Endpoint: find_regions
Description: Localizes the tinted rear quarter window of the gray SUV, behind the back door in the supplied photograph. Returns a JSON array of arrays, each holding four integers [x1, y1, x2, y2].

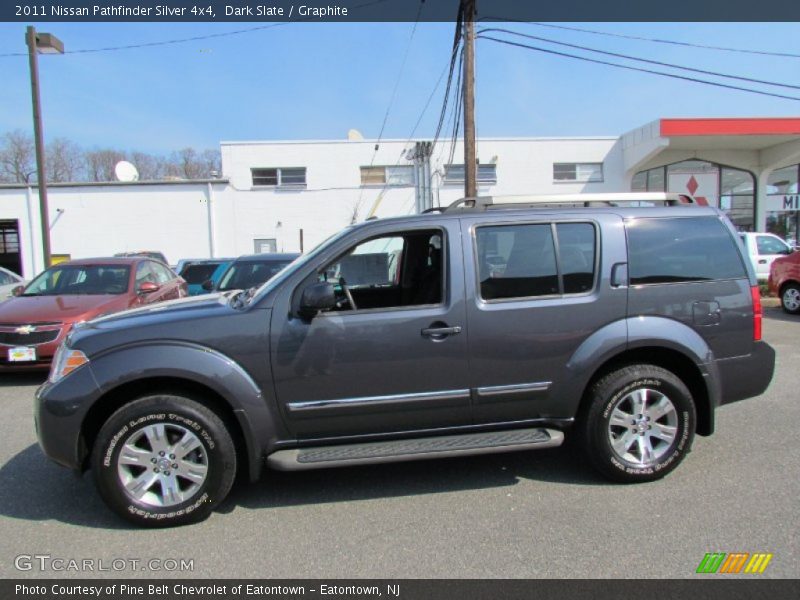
[[626, 217, 747, 285]]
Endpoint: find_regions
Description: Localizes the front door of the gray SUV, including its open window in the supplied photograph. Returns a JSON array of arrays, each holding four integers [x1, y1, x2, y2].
[[271, 220, 470, 438]]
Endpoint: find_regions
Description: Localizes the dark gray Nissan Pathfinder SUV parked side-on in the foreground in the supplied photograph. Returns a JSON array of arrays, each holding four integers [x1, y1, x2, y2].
[[36, 194, 775, 525]]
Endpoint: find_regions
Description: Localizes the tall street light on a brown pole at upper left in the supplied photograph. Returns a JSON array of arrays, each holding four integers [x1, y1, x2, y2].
[[25, 26, 64, 269]]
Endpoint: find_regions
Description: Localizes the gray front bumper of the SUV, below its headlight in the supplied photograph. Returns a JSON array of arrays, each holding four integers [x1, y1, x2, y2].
[[34, 364, 100, 471]]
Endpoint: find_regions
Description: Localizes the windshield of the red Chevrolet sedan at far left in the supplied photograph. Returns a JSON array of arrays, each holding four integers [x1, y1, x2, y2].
[[21, 265, 131, 296]]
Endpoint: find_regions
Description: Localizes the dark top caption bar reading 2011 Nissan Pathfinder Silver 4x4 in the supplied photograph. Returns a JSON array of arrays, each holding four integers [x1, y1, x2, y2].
[[0, 0, 800, 22]]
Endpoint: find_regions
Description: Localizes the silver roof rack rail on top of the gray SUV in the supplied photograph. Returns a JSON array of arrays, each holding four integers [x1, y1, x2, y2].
[[444, 192, 698, 212]]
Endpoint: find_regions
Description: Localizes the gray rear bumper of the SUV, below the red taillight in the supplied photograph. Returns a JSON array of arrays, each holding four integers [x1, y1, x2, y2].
[[717, 342, 775, 404]]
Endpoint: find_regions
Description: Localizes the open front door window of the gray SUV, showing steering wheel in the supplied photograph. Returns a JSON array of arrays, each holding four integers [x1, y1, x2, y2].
[[319, 229, 445, 311]]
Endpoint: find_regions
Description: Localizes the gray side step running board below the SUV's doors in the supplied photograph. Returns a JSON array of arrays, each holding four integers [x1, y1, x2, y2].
[[267, 428, 564, 471]]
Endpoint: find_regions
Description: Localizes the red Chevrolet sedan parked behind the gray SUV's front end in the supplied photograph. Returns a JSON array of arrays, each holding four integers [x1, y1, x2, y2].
[[0, 257, 187, 370]]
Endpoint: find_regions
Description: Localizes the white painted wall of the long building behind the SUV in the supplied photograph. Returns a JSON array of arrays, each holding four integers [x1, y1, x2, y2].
[[0, 138, 644, 277]]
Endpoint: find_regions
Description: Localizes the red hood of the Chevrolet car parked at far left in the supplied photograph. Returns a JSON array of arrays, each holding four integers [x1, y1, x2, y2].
[[0, 294, 128, 323]]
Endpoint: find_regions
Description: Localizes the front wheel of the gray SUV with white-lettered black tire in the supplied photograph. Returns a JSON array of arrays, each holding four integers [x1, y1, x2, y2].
[[92, 394, 236, 527]]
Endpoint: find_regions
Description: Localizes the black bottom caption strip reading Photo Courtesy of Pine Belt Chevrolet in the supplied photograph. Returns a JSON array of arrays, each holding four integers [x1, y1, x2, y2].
[[0, 576, 800, 600]]
